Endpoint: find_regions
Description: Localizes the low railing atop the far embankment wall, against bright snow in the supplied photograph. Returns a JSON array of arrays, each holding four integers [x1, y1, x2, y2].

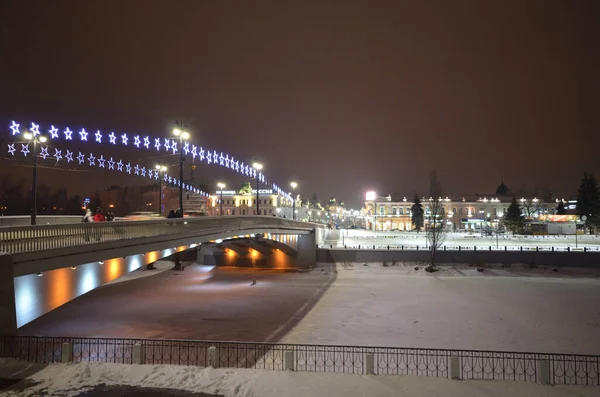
[[317, 244, 600, 252]]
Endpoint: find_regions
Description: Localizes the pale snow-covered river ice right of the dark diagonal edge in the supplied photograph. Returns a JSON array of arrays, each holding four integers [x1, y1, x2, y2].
[[282, 263, 600, 354]]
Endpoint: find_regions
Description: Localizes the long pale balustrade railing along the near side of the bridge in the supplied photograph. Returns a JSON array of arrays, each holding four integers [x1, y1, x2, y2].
[[0, 216, 315, 254]]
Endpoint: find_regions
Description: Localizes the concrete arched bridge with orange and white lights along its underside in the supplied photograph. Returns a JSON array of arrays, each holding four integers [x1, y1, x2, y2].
[[0, 216, 322, 333]]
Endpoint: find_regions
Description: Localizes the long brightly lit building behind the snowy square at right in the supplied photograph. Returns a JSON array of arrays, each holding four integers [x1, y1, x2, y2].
[[362, 183, 568, 231]]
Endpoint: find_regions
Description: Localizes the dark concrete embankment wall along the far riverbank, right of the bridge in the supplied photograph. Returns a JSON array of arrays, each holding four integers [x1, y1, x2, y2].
[[317, 249, 600, 267]]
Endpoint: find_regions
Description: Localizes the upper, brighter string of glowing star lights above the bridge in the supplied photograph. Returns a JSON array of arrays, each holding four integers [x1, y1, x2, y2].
[[9, 121, 294, 200]]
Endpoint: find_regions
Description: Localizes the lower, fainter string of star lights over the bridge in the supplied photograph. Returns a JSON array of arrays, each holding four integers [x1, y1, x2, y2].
[[8, 138, 209, 197]]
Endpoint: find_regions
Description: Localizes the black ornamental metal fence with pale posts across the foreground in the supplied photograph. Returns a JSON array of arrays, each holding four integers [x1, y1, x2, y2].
[[0, 336, 600, 386]]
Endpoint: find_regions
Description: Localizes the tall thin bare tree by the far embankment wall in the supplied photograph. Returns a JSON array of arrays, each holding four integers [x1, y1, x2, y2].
[[425, 170, 446, 272]]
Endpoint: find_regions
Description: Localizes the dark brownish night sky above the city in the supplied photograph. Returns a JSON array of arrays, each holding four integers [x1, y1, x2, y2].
[[0, 0, 600, 205]]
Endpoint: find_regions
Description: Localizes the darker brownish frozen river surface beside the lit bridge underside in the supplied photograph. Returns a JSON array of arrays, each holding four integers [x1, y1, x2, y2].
[[18, 265, 336, 342]]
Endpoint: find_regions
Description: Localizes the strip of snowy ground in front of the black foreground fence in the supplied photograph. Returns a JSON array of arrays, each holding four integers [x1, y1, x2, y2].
[[0, 360, 599, 397]]
